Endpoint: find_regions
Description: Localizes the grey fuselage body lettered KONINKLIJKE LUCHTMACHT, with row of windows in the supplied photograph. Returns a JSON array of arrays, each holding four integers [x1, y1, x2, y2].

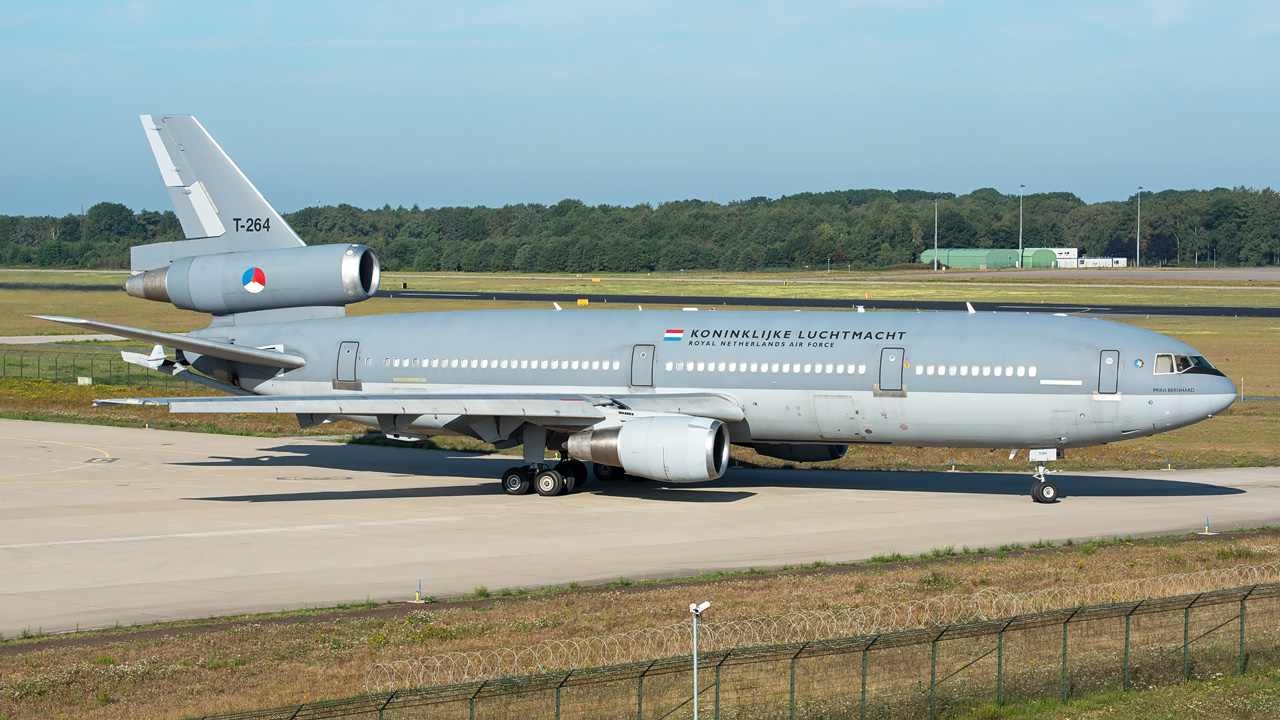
[[192, 310, 1236, 448]]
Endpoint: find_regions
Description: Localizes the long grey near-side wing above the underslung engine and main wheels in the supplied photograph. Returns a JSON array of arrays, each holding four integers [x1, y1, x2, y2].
[[93, 392, 744, 425]]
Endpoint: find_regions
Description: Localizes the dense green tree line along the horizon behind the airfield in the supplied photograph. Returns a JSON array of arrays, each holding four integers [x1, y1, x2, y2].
[[0, 187, 1280, 273]]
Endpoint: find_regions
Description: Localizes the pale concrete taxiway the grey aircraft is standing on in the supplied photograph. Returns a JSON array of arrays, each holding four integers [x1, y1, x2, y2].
[[0, 420, 1280, 637]]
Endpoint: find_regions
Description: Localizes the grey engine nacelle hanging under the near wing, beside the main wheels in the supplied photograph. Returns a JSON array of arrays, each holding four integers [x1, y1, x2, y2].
[[567, 415, 728, 483]]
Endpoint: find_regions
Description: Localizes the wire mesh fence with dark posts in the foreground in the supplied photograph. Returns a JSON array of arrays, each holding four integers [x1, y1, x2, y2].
[[189, 583, 1280, 720]]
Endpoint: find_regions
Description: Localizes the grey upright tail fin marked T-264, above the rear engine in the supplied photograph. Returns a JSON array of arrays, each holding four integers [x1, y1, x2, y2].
[[131, 115, 305, 273]]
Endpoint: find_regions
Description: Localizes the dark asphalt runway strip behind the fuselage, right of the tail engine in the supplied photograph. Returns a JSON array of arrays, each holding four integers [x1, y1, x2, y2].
[[381, 290, 1280, 318]]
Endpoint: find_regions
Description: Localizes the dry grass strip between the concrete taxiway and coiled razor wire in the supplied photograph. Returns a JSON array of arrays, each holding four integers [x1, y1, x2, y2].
[[0, 534, 1280, 719]]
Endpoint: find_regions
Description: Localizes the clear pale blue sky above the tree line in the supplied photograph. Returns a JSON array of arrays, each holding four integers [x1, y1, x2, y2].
[[0, 0, 1280, 215]]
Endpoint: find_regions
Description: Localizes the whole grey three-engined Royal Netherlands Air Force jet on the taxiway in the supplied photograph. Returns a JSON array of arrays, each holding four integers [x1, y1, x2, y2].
[[46, 115, 1236, 502]]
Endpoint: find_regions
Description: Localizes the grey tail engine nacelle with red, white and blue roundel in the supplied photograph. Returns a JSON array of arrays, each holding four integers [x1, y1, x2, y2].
[[124, 245, 381, 315]]
